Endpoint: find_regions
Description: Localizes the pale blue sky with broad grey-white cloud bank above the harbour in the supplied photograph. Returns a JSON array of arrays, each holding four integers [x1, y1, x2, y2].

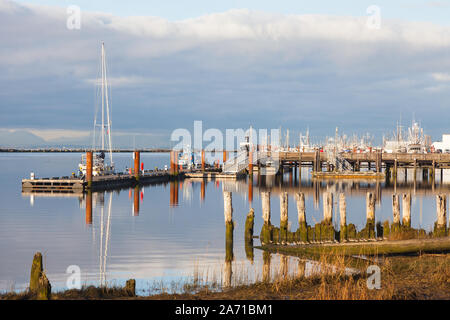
[[0, 0, 450, 146]]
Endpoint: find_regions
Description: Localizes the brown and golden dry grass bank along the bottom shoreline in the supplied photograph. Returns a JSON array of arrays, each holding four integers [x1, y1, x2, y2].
[[0, 254, 450, 300]]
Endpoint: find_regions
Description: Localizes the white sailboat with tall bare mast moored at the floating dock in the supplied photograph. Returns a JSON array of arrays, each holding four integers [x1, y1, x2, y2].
[[78, 42, 115, 176]]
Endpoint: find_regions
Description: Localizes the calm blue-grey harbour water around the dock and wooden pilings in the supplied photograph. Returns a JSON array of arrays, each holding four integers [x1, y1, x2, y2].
[[0, 153, 450, 294]]
